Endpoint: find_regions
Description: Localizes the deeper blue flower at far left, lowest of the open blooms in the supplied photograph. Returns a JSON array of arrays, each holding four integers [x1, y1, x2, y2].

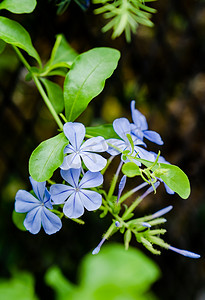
[[15, 177, 62, 234]]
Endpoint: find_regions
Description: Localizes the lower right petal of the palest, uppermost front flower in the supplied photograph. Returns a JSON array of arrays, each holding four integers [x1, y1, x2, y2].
[[81, 152, 107, 172]]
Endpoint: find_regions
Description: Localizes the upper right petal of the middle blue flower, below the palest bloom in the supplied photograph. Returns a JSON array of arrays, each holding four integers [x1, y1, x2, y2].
[[79, 171, 103, 189]]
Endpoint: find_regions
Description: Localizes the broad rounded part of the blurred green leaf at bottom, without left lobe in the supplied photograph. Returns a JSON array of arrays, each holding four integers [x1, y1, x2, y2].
[[79, 244, 160, 299]]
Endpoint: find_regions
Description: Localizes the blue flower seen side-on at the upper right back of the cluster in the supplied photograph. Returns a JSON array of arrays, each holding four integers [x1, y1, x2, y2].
[[131, 100, 164, 145]]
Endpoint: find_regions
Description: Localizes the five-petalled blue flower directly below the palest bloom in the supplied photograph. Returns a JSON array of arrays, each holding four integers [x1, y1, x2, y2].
[[50, 169, 103, 219]]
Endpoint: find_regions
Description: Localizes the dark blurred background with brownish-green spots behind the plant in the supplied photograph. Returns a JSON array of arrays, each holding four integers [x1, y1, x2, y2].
[[0, 0, 205, 300]]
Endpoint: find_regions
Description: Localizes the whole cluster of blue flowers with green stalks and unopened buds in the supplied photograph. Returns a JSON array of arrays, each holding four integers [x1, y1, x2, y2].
[[15, 101, 199, 258]]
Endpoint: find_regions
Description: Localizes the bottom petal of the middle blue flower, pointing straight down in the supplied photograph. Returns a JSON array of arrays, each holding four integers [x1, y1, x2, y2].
[[63, 192, 84, 219]]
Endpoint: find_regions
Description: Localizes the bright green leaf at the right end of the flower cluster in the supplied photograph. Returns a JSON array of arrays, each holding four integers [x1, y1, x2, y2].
[[138, 159, 190, 199]]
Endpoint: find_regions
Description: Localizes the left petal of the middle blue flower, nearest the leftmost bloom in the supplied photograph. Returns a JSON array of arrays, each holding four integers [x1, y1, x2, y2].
[[50, 184, 75, 204]]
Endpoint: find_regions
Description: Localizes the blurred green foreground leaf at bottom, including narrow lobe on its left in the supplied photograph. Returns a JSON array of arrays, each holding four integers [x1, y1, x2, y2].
[[46, 244, 160, 300]]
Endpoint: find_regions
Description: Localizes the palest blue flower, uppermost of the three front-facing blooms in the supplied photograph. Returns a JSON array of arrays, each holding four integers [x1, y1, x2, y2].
[[60, 122, 108, 172]]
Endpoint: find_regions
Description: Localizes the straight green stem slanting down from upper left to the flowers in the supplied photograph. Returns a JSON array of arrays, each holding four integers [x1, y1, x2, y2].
[[13, 46, 63, 129]]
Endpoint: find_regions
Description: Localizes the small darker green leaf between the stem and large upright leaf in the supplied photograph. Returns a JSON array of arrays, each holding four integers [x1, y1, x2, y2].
[[41, 78, 64, 114]]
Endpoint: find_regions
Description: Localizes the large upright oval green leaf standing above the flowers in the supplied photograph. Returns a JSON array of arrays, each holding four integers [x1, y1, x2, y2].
[[64, 48, 120, 121]]
